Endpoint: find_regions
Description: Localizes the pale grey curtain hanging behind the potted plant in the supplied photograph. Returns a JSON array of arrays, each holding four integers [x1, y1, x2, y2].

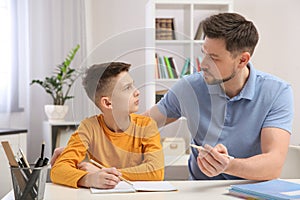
[[26, 0, 86, 160]]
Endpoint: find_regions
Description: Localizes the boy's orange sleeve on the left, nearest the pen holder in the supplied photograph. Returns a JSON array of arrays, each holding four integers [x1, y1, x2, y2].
[[50, 122, 88, 188]]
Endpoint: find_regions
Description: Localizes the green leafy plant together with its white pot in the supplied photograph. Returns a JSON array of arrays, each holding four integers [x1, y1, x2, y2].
[[30, 44, 80, 122]]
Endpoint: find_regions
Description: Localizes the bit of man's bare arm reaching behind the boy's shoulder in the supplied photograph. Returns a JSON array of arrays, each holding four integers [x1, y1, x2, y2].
[[142, 105, 177, 128]]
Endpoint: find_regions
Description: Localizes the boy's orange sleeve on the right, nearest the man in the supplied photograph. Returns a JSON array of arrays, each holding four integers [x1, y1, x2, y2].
[[120, 120, 164, 181]]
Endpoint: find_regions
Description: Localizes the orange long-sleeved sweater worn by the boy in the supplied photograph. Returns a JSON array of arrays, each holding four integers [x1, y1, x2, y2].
[[51, 114, 164, 188]]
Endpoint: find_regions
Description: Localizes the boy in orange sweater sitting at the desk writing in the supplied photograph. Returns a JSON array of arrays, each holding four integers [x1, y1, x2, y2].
[[51, 62, 164, 188]]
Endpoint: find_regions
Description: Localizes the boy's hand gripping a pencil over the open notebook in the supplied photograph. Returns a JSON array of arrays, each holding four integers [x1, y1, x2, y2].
[[78, 167, 121, 189]]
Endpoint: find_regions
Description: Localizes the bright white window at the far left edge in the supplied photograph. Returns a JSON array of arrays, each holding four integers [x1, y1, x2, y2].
[[0, 0, 23, 112]]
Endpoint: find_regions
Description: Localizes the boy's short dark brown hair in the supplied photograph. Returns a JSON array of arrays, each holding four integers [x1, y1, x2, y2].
[[82, 62, 131, 108]]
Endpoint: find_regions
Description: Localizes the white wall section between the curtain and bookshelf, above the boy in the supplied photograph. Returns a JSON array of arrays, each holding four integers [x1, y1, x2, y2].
[[86, 0, 147, 112]]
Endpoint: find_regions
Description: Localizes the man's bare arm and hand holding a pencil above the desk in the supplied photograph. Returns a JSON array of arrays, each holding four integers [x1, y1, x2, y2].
[[197, 128, 290, 180]]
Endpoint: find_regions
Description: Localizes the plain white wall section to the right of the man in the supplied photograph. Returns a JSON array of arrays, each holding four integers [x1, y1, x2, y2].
[[234, 0, 300, 144]]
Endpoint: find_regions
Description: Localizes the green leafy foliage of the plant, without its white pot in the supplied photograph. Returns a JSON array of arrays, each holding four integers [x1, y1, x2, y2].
[[30, 44, 80, 105]]
